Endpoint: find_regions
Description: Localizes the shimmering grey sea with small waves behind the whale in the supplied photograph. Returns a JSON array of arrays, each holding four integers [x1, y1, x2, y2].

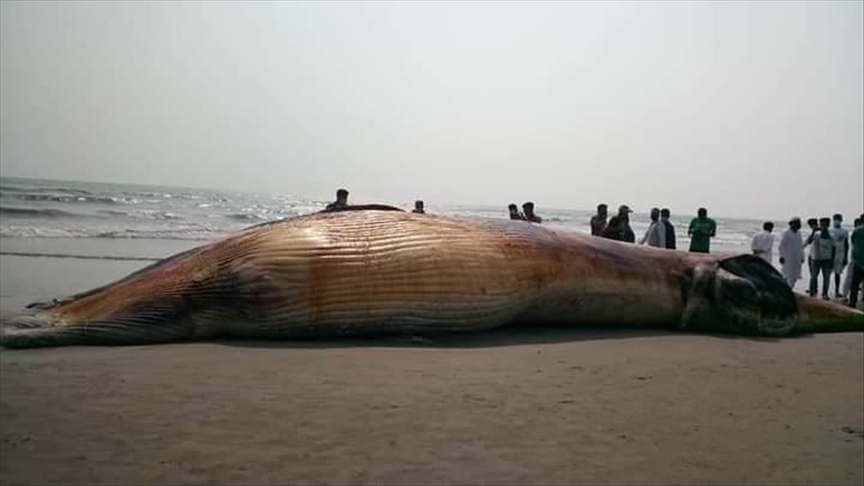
[[0, 177, 785, 258]]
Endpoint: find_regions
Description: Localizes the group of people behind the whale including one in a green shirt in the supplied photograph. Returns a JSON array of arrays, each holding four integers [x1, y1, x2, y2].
[[591, 204, 717, 253]]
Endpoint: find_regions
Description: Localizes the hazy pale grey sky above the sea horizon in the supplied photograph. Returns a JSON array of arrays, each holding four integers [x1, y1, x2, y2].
[[0, 1, 864, 220]]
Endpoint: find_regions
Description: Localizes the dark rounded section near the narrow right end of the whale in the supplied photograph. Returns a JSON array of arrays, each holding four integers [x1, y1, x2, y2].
[[681, 255, 798, 336]]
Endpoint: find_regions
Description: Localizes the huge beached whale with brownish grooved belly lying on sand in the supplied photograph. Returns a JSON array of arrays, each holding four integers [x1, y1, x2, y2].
[[0, 205, 864, 347]]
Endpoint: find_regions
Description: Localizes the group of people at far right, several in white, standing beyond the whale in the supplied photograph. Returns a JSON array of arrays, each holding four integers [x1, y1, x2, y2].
[[776, 214, 864, 307]]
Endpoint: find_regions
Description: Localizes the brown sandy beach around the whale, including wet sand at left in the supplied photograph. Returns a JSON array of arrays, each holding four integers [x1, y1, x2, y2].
[[0, 241, 864, 484]]
